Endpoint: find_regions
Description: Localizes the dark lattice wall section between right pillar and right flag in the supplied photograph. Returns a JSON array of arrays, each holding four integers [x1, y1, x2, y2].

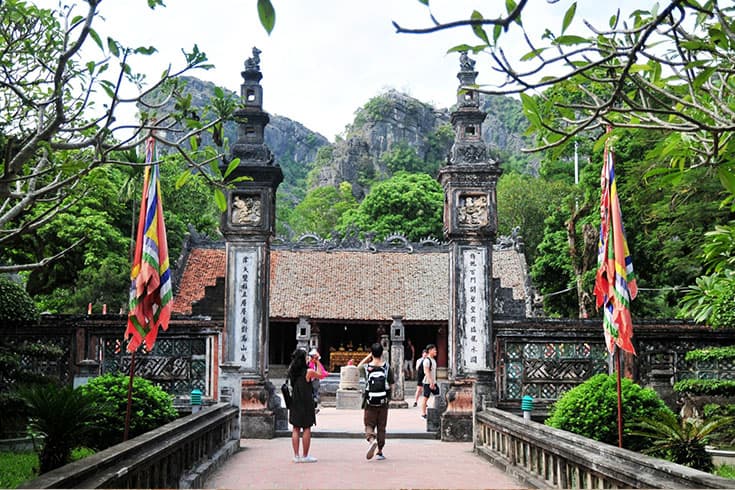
[[499, 340, 607, 401]]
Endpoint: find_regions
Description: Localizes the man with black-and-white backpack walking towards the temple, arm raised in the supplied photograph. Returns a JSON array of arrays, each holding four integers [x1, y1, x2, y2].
[[357, 342, 395, 460]]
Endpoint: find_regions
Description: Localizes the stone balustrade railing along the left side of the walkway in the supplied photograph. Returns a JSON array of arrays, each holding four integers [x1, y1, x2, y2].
[[22, 403, 240, 488]]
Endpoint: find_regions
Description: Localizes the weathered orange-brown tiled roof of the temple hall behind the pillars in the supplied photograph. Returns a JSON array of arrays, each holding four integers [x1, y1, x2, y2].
[[174, 248, 525, 321]]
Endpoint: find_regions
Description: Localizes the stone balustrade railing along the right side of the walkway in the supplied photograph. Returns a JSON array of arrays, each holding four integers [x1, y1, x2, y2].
[[475, 408, 733, 488]]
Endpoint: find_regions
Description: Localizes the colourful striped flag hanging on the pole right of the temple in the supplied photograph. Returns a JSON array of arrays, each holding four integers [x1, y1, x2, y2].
[[595, 127, 638, 354]]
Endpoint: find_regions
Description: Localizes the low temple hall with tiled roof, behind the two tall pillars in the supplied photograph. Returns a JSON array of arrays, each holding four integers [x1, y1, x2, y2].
[[174, 230, 533, 371]]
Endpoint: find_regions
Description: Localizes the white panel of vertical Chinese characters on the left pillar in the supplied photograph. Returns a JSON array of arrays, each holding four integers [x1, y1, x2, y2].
[[235, 251, 258, 368]]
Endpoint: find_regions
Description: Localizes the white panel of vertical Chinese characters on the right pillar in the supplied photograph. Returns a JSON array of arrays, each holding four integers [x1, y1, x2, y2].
[[459, 249, 488, 372]]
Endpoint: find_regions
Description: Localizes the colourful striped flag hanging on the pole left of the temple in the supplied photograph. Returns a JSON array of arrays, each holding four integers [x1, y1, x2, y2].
[[125, 138, 173, 352]]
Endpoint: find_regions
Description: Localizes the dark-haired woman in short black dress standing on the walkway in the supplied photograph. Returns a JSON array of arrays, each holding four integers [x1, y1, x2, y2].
[[288, 349, 319, 463]]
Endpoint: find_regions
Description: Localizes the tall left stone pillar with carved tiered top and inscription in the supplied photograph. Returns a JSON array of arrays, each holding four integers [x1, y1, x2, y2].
[[220, 48, 283, 438]]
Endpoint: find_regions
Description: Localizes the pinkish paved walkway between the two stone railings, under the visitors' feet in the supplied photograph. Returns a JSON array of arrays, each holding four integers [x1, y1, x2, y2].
[[205, 408, 526, 489]]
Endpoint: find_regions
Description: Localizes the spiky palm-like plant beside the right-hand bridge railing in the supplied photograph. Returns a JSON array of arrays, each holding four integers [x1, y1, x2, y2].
[[631, 411, 735, 472]]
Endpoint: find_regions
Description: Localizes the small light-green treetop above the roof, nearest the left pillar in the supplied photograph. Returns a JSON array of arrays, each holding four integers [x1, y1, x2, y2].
[[289, 182, 358, 238]]
